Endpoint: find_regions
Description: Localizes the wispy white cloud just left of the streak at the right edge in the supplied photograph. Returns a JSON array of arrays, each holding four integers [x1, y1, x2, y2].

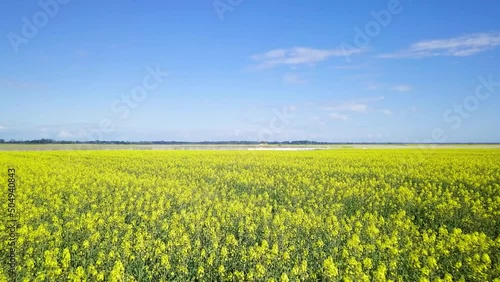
[[251, 47, 364, 69]]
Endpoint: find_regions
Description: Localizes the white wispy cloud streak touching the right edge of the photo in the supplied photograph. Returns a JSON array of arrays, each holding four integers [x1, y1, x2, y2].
[[378, 33, 500, 58]]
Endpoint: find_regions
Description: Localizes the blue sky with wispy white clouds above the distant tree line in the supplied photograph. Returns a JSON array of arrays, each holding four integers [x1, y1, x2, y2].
[[0, 0, 500, 142]]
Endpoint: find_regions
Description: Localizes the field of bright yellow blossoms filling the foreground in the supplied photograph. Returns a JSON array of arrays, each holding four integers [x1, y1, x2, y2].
[[0, 149, 500, 281]]
